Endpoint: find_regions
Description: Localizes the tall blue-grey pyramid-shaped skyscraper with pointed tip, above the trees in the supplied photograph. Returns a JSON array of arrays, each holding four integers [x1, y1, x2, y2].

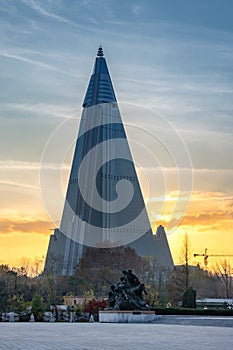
[[45, 47, 173, 275]]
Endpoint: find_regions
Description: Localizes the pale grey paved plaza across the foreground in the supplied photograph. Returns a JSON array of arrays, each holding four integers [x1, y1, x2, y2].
[[0, 322, 233, 350]]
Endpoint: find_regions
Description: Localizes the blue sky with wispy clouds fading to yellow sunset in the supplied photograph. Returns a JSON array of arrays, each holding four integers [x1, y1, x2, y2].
[[0, 0, 233, 266]]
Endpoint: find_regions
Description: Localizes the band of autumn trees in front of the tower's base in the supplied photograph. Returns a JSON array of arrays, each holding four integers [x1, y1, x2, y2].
[[0, 243, 233, 313]]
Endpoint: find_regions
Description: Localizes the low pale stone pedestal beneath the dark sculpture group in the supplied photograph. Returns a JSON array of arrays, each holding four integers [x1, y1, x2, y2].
[[99, 310, 157, 323]]
